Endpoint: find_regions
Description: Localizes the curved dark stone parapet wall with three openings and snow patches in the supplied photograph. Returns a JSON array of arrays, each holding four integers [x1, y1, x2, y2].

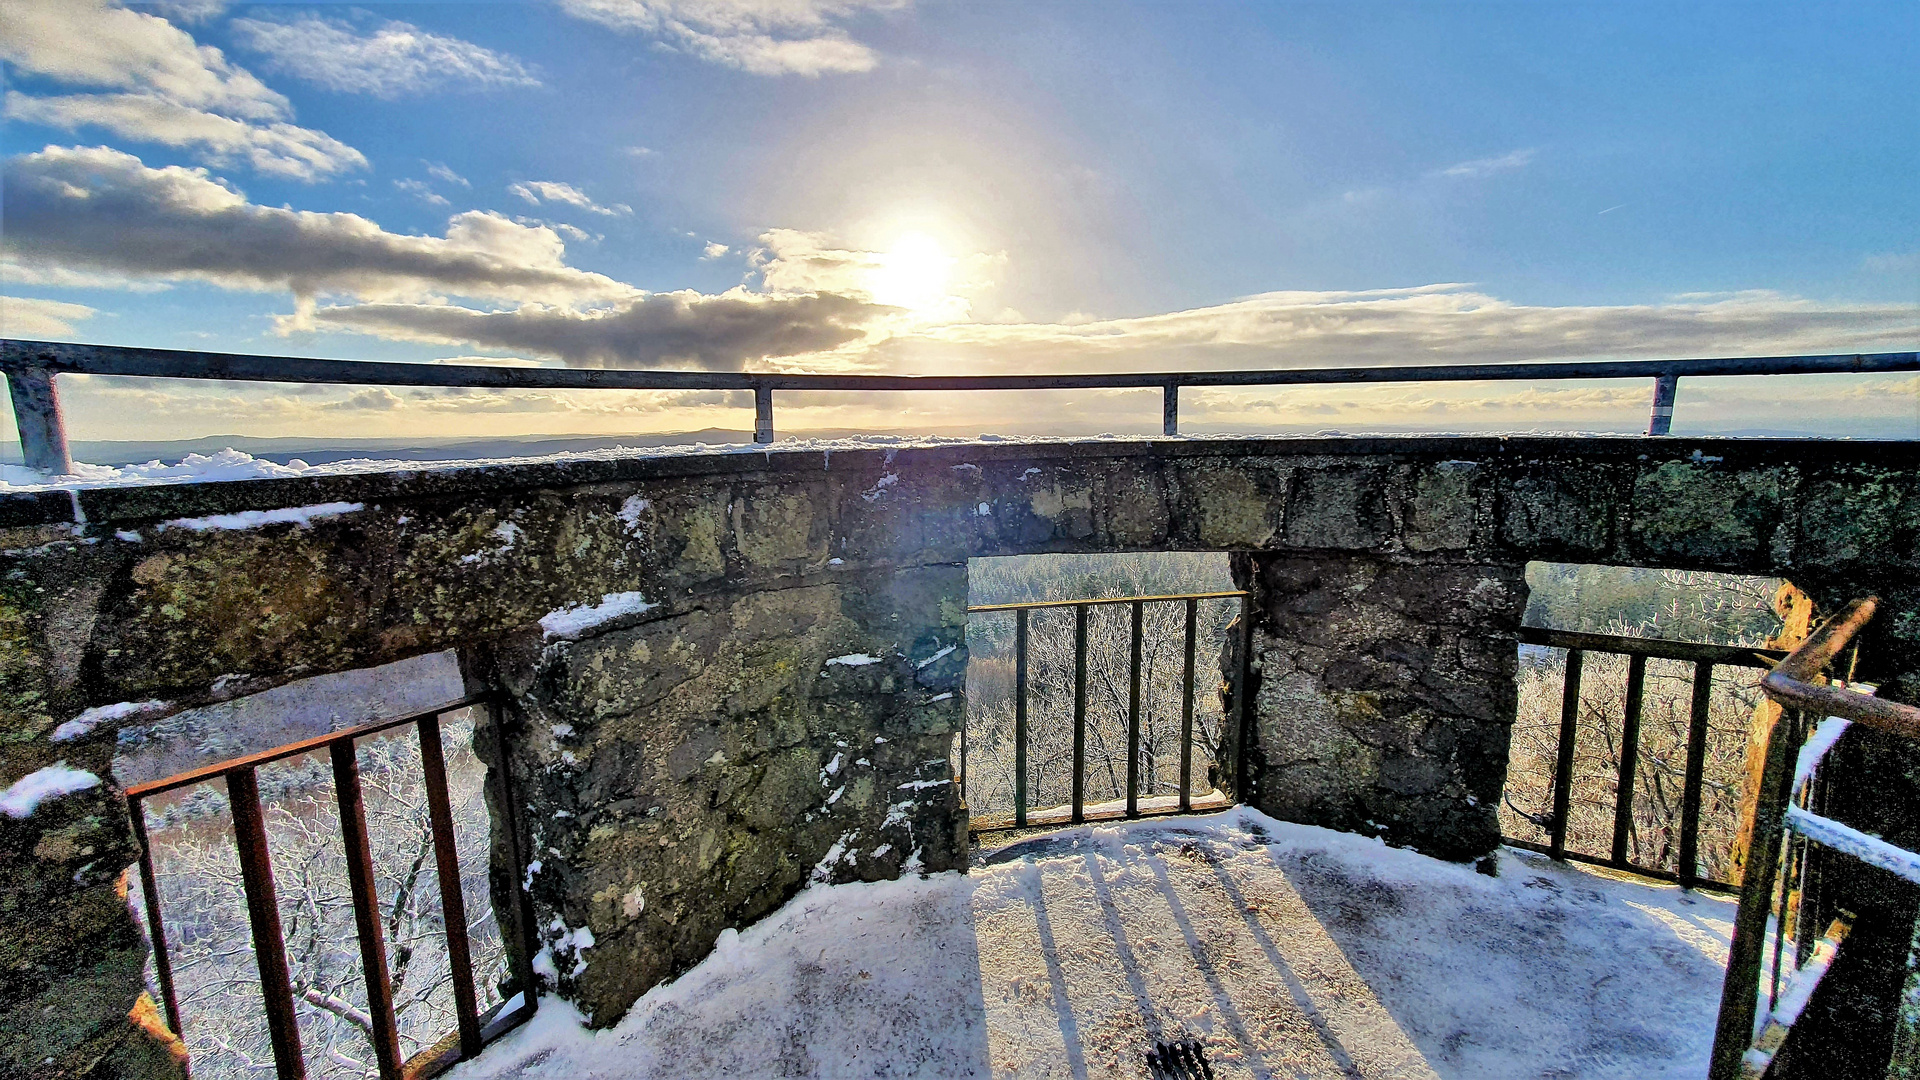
[[0, 438, 1920, 1076]]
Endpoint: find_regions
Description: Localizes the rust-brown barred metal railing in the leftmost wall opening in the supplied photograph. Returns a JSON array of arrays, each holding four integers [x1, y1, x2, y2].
[[127, 696, 538, 1080]]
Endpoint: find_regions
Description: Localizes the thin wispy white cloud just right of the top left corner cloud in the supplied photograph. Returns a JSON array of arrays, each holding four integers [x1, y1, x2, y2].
[[232, 13, 540, 98]]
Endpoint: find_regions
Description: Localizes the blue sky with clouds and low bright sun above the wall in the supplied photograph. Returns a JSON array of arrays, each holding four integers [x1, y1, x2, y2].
[[0, 0, 1920, 440]]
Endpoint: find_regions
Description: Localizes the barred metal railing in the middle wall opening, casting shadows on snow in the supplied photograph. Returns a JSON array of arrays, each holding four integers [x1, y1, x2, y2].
[[960, 590, 1252, 832]]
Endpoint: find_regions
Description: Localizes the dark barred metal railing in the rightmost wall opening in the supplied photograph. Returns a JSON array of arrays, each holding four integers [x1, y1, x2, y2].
[[1501, 626, 1788, 892]]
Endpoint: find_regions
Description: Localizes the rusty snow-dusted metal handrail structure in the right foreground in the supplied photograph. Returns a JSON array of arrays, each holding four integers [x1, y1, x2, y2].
[[1709, 598, 1920, 1080]]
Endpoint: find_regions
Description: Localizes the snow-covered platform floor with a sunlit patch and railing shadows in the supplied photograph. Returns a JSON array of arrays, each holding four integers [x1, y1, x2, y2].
[[451, 809, 1734, 1080]]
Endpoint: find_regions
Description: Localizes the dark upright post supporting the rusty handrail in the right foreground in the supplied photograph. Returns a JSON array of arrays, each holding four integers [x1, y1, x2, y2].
[[1712, 709, 1793, 1080]]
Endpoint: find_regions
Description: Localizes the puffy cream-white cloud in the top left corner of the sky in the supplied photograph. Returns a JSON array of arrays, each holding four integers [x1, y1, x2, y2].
[[0, 0, 367, 181]]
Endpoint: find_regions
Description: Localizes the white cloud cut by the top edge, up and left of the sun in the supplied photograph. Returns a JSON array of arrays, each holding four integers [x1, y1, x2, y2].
[[561, 0, 912, 77]]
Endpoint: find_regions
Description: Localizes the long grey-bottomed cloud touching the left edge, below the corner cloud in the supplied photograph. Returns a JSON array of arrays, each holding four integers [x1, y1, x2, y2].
[[0, 146, 636, 302]]
